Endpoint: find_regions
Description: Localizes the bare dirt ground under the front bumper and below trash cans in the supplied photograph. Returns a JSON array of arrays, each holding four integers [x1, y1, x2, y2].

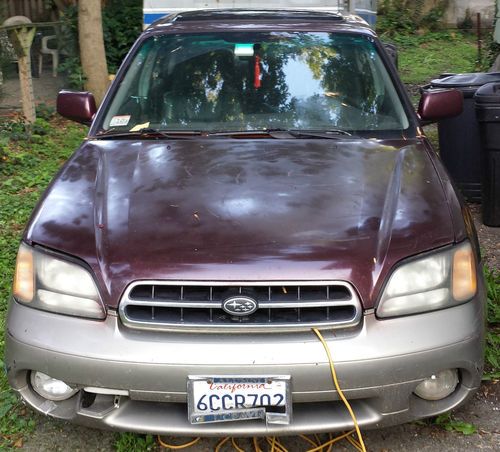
[[16, 204, 500, 452]]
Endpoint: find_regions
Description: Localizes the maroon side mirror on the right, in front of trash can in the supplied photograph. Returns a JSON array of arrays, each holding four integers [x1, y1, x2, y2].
[[418, 89, 464, 122]]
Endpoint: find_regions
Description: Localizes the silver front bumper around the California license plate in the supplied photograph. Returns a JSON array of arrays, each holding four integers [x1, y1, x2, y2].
[[6, 297, 484, 436]]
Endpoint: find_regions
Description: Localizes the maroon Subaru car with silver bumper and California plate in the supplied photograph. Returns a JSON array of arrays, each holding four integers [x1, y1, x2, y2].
[[6, 10, 485, 436]]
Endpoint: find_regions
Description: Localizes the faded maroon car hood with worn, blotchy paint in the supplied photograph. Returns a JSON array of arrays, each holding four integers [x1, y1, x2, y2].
[[25, 138, 454, 307]]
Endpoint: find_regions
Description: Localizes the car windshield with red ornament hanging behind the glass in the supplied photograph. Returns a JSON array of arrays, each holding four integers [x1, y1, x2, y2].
[[100, 32, 409, 132]]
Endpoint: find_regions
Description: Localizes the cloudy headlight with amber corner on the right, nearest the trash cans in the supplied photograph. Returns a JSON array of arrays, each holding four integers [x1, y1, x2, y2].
[[377, 242, 477, 317]]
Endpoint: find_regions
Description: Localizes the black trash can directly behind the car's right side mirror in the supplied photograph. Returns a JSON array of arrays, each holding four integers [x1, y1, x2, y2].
[[429, 72, 500, 202]]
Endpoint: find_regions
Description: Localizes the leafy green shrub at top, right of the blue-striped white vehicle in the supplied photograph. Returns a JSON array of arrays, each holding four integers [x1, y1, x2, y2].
[[377, 0, 449, 36]]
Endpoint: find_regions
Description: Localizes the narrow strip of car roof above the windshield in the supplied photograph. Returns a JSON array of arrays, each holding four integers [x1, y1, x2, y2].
[[145, 8, 375, 35]]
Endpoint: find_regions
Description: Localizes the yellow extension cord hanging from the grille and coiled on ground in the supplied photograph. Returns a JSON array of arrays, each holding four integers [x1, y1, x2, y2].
[[158, 328, 366, 452]]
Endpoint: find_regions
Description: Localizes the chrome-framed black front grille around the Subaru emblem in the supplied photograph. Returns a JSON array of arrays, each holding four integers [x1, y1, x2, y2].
[[119, 281, 361, 332]]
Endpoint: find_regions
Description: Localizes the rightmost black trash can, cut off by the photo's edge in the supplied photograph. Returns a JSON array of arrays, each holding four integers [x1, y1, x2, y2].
[[474, 82, 500, 226]]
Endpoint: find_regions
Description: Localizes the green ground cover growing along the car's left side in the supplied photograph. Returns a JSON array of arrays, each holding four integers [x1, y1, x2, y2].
[[0, 116, 85, 450]]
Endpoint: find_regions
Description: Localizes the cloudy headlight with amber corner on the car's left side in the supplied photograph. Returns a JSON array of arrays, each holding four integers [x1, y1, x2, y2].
[[13, 244, 106, 319]]
